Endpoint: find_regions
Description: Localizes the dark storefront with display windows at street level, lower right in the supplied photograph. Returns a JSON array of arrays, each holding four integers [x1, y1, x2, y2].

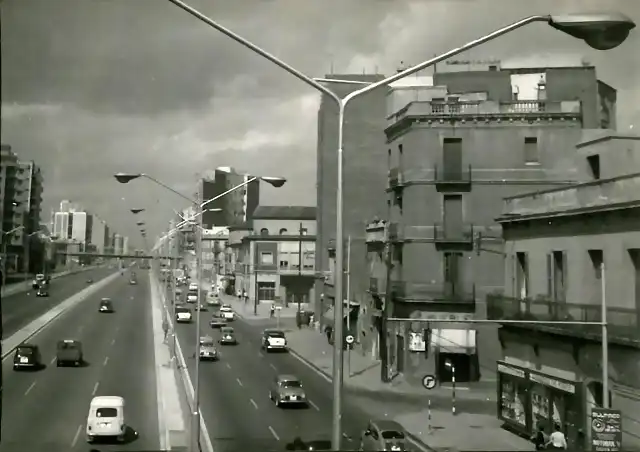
[[497, 361, 584, 447]]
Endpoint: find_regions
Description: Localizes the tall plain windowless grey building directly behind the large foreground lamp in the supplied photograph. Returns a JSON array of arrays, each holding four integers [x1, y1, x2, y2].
[[314, 74, 388, 321]]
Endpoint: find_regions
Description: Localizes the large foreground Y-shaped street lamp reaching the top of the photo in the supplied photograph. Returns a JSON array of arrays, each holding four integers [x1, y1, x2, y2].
[[161, 0, 635, 450]]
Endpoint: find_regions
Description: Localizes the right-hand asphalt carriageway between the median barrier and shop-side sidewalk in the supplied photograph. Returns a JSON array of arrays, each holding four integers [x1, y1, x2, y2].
[[177, 298, 404, 452]]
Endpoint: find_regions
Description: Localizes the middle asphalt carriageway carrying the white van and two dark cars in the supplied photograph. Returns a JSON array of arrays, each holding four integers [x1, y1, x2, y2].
[[0, 270, 160, 452]]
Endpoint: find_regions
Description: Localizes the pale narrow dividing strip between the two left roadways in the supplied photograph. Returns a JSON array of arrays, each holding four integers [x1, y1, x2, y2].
[[1, 272, 120, 361]]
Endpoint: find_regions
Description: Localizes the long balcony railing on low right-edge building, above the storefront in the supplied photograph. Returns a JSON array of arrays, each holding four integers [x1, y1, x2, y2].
[[487, 295, 640, 345]]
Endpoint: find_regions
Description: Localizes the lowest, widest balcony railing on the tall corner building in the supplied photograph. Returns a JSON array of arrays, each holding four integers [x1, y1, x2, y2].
[[391, 281, 476, 305]]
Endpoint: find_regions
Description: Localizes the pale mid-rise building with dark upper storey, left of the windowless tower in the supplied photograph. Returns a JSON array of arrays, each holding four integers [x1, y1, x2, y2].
[[228, 206, 316, 304]]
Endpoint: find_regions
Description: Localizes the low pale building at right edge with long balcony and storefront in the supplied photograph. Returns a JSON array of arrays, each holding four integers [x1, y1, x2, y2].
[[487, 131, 640, 450]]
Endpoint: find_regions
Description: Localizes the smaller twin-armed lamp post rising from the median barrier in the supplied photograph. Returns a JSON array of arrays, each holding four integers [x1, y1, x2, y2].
[[114, 173, 286, 451]]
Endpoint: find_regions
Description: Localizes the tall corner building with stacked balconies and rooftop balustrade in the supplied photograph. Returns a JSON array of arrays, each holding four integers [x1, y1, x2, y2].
[[371, 58, 615, 384]]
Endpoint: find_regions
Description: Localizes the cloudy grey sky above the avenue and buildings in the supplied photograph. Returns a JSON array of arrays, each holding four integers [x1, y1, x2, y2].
[[0, 0, 640, 246]]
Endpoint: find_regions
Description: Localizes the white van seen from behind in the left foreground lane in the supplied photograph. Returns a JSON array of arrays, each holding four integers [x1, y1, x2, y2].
[[87, 396, 127, 443]]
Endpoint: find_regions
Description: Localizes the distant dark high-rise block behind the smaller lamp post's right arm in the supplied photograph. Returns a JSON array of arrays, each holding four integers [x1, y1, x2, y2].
[[201, 167, 260, 229]]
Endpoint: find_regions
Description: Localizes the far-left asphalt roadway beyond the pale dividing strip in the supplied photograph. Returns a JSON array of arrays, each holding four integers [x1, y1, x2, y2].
[[2, 267, 116, 339]]
